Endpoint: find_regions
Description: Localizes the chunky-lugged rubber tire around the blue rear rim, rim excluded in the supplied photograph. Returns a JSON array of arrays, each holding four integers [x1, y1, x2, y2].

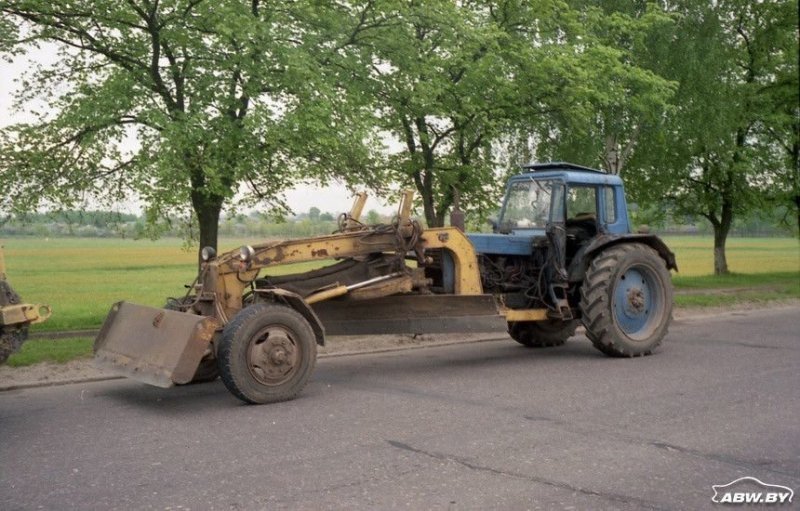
[[580, 243, 673, 357]]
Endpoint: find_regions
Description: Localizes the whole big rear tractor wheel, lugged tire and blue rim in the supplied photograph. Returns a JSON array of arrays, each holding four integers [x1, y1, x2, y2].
[[580, 243, 672, 357]]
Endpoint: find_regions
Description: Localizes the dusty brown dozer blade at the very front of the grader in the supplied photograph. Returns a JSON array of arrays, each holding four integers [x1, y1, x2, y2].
[[94, 302, 217, 388]]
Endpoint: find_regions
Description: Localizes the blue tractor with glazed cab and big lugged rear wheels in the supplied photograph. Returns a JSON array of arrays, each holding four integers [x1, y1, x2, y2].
[[469, 162, 677, 357]]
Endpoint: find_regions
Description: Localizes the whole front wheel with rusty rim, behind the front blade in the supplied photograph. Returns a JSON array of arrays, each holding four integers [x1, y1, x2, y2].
[[217, 303, 317, 404]]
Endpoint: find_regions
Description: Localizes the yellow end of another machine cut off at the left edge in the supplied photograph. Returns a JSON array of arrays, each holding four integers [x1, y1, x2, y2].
[[0, 246, 51, 364]]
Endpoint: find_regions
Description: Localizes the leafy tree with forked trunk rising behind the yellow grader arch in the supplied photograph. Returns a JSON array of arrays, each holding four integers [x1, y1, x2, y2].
[[360, 0, 584, 226]]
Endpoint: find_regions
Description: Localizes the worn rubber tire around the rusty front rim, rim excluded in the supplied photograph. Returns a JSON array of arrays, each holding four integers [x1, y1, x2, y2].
[[217, 303, 317, 404]]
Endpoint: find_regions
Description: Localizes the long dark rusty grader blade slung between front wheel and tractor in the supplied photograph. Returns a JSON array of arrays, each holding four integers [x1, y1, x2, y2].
[[313, 295, 507, 335]]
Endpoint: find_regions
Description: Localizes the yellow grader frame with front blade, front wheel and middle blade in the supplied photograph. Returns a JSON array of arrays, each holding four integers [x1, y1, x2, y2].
[[94, 192, 543, 403]]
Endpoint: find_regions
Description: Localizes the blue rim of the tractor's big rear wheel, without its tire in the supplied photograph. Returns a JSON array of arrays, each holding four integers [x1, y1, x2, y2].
[[613, 265, 664, 340]]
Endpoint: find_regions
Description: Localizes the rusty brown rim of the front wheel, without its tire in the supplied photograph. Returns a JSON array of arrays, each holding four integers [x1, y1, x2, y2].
[[247, 325, 300, 386]]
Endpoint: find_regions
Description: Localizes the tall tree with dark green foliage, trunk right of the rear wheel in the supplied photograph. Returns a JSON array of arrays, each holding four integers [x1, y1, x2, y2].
[[639, 0, 796, 274]]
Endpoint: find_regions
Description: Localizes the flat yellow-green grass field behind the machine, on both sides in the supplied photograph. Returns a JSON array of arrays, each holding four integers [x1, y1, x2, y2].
[[3, 237, 800, 330]]
